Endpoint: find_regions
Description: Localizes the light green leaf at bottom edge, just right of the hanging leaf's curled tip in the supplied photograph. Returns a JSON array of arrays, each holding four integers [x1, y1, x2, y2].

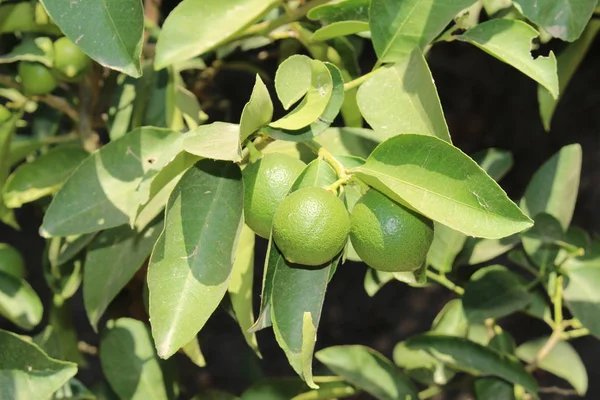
[[316, 345, 418, 400]]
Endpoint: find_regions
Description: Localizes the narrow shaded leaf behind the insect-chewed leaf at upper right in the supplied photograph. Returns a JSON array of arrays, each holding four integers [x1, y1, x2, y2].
[[538, 19, 600, 131]]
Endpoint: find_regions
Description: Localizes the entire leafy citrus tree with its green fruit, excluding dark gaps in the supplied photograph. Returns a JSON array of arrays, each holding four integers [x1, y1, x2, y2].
[[0, 0, 600, 400]]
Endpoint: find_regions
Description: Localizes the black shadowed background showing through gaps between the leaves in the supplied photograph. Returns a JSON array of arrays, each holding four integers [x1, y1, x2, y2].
[[0, 7, 600, 399]]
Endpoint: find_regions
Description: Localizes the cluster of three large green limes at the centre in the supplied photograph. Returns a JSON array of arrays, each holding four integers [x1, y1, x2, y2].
[[243, 153, 433, 272]]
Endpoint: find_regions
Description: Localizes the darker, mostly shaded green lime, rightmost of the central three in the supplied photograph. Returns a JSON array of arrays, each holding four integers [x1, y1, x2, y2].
[[350, 189, 433, 272]]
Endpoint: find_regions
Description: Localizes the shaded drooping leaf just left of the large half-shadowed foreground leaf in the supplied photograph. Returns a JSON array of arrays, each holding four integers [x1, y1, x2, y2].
[[83, 219, 163, 330]]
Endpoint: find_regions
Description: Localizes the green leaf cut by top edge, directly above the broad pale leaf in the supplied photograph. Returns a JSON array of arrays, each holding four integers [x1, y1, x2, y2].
[[369, 0, 474, 63]]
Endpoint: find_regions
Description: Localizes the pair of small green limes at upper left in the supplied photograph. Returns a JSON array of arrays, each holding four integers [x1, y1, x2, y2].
[[19, 36, 92, 95]]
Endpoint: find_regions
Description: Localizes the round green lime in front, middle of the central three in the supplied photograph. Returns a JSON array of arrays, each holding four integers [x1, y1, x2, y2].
[[273, 187, 350, 266]]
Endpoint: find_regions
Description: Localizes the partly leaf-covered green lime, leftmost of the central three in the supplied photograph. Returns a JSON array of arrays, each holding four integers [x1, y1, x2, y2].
[[243, 153, 306, 239]]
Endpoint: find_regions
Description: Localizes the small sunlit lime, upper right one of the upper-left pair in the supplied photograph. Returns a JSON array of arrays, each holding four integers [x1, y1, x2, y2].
[[54, 36, 92, 82]]
